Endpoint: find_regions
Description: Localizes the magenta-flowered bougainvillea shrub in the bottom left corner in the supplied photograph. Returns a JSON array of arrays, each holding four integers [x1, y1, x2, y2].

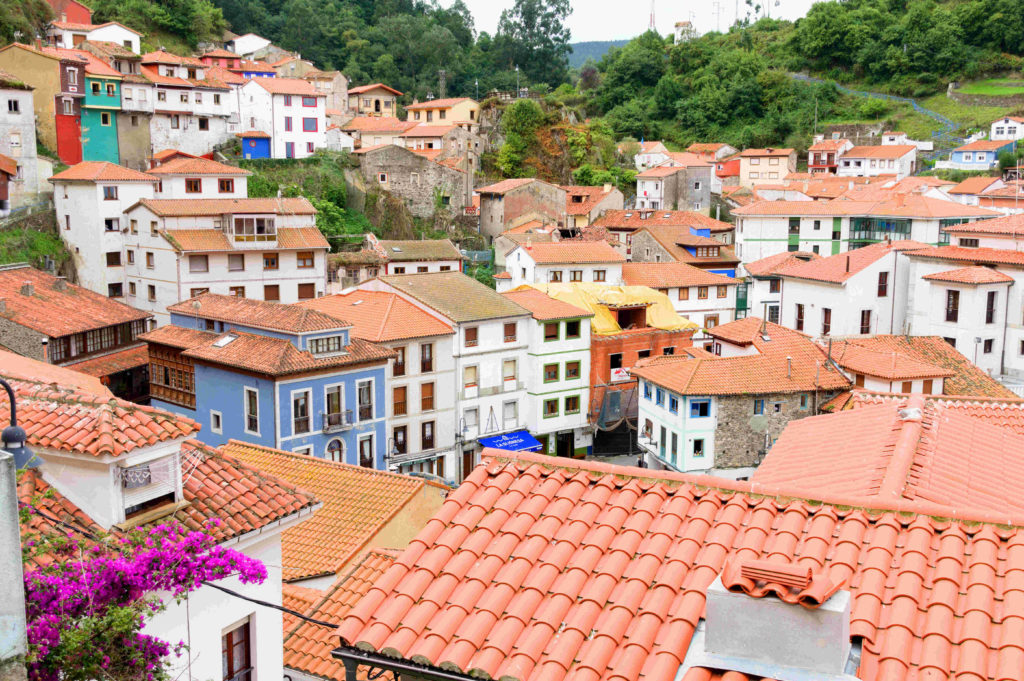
[[25, 510, 266, 681]]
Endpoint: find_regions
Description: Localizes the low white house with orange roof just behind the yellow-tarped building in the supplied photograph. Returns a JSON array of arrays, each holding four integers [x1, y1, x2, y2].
[[499, 241, 626, 291]]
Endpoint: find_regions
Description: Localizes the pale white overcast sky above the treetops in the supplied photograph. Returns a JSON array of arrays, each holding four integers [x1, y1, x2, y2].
[[448, 0, 814, 42]]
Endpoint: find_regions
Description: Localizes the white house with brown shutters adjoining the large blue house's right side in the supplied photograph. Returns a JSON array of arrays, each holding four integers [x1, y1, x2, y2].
[[298, 291, 461, 480]]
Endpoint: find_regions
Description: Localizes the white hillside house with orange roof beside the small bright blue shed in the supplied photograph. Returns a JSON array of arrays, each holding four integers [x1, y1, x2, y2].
[[239, 78, 327, 159]]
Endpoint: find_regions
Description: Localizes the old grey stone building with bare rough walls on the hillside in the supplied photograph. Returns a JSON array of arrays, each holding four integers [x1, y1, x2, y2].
[[354, 144, 471, 217]]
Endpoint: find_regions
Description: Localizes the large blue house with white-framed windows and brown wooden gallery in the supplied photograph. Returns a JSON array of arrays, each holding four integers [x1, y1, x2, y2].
[[140, 293, 394, 470]]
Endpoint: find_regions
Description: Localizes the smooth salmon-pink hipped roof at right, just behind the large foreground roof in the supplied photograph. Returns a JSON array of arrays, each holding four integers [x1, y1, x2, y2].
[[753, 395, 1024, 514]]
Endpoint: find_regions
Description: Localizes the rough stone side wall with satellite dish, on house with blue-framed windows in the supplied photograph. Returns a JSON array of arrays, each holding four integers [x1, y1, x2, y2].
[[715, 393, 824, 468]]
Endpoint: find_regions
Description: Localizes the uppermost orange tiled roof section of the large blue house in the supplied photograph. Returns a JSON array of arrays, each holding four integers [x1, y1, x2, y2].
[[167, 293, 350, 334]]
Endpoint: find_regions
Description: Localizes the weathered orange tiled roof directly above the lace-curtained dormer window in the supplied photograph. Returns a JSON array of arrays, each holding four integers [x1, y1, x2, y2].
[[0, 379, 200, 457]]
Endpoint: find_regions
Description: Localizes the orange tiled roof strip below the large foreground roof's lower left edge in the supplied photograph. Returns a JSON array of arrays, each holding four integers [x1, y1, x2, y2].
[[284, 549, 401, 681]]
